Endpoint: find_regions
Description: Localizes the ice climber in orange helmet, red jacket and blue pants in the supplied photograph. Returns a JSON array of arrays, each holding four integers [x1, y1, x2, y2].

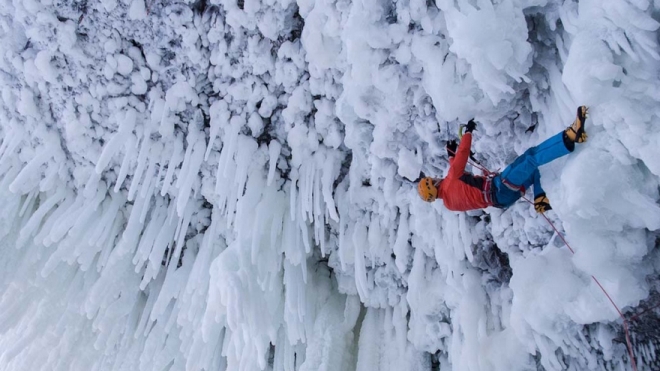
[[417, 106, 588, 213]]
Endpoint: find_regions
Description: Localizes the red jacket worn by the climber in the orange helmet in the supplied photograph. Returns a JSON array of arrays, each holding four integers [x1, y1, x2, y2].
[[438, 133, 492, 211]]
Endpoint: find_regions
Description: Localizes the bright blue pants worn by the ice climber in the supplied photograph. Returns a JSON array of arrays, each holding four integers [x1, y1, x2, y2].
[[493, 132, 573, 208]]
